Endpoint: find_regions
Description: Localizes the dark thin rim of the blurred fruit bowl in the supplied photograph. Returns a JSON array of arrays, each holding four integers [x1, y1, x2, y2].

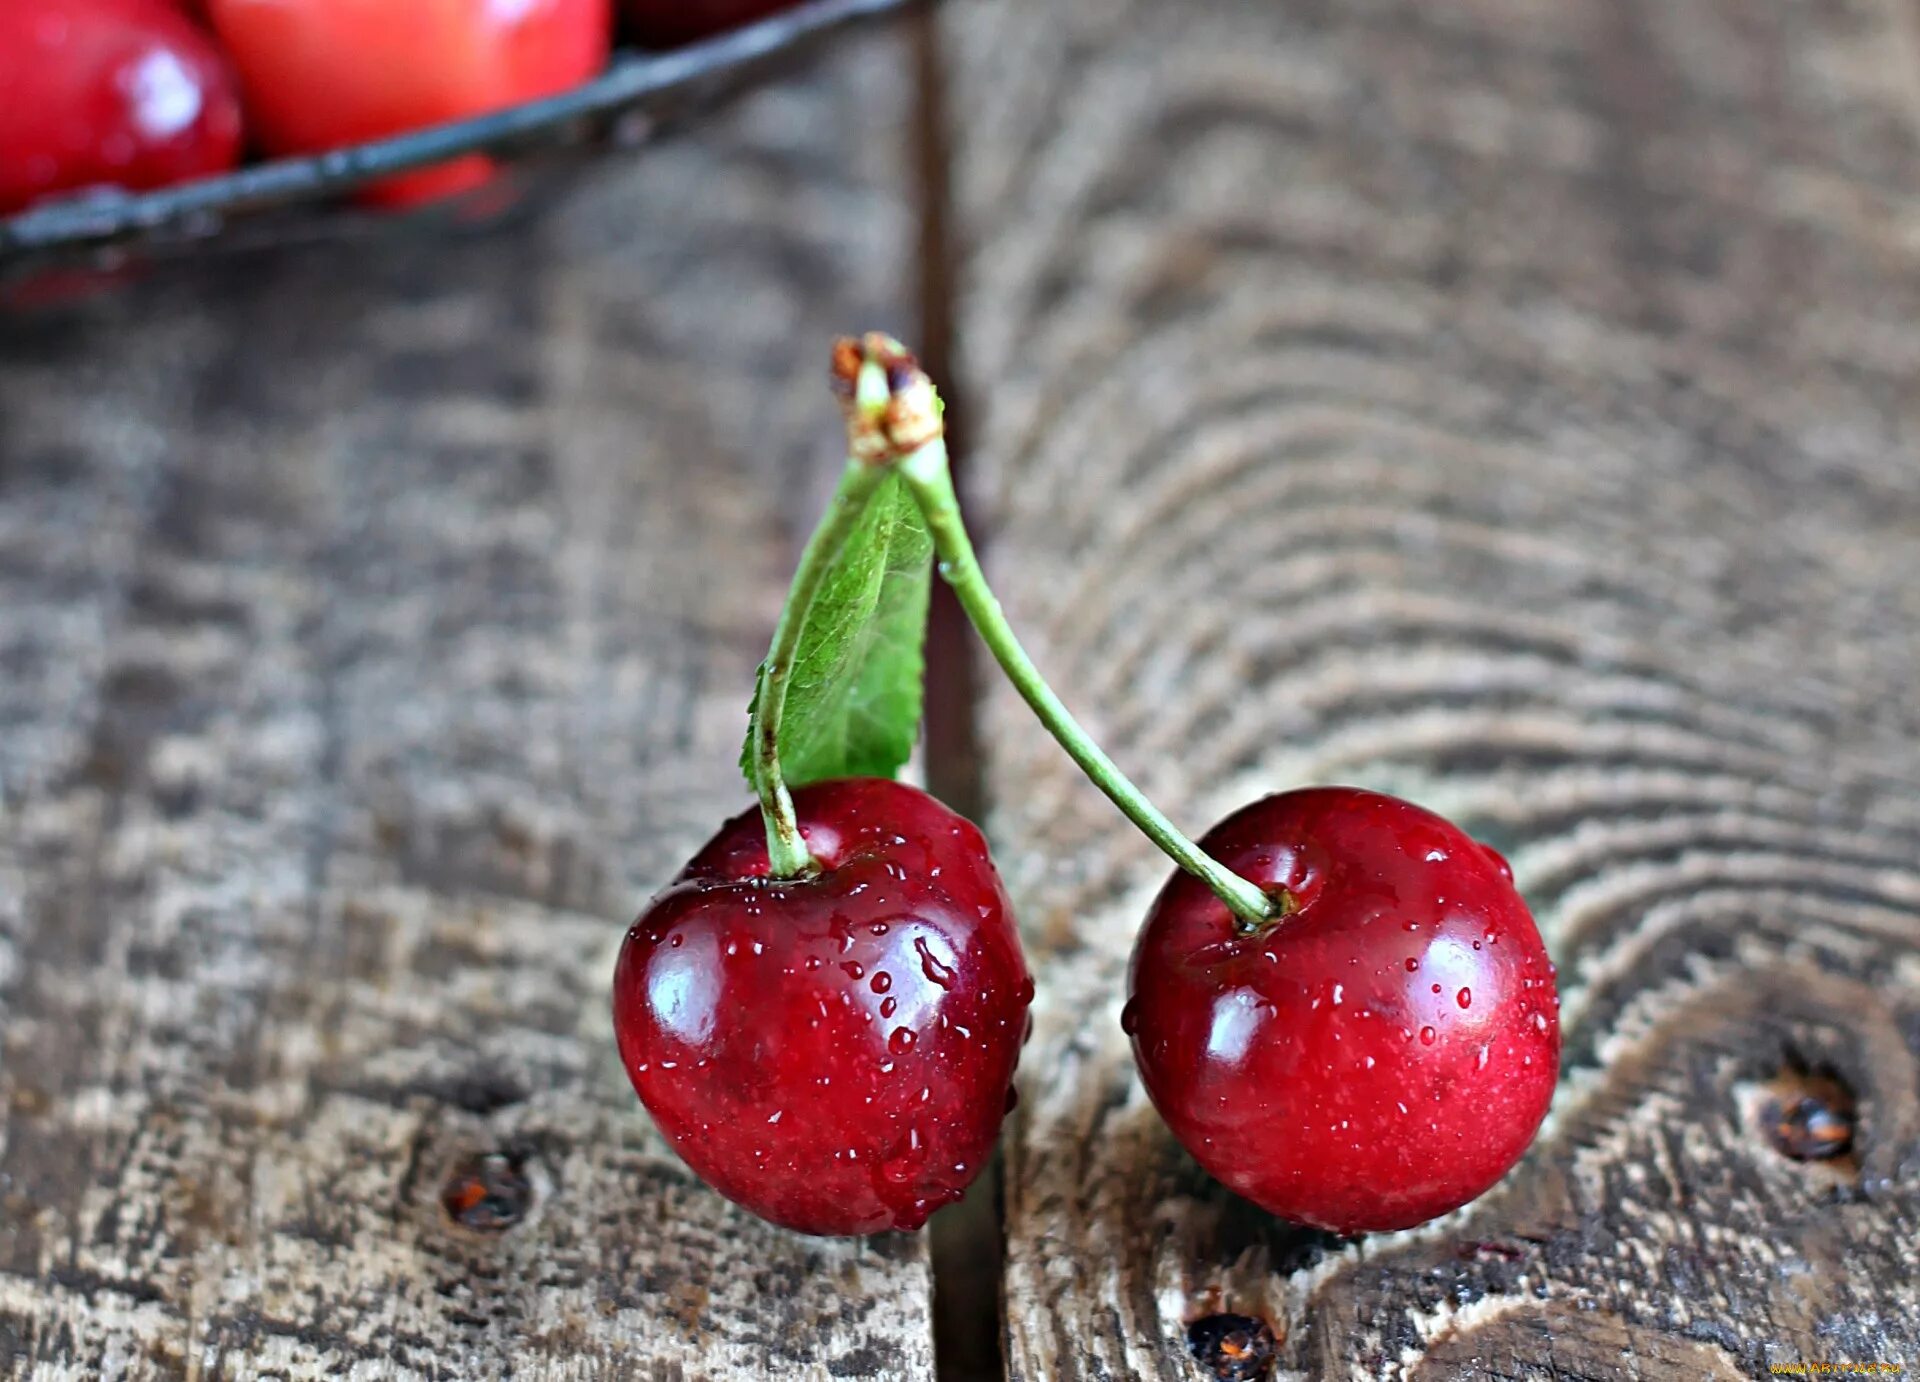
[[0, 0, 912, 286]]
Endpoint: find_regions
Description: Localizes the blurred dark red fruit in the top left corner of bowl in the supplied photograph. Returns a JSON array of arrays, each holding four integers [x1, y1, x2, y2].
[[0, 0, 240, 211]]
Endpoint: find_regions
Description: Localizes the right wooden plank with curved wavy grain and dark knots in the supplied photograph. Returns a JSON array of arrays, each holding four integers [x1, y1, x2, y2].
[[943, 0, 1920, 1380]]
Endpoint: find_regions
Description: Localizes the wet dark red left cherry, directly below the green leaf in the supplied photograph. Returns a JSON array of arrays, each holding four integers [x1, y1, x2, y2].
[[612, 777, 1033, 1234]]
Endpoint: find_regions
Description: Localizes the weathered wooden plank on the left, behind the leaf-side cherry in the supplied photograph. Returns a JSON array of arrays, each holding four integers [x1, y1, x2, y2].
[[0, 33, 933, 1378]]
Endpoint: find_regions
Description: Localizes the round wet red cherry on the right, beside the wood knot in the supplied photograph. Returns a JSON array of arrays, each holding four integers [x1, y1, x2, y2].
[[1121, 787, 1559, 1234]]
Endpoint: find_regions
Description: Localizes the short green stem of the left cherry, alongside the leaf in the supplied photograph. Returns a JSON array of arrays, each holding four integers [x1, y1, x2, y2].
[[753, 461, 887, 877]]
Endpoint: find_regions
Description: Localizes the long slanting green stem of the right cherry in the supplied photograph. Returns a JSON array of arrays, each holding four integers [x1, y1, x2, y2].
[[899, 438, 1286, 927]]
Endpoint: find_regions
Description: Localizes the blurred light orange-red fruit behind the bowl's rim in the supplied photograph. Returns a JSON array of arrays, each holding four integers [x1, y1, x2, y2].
[[207, 0, 612, 205]]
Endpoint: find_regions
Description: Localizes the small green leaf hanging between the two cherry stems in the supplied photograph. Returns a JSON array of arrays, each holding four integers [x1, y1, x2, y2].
[[741, 476, 933, 787]]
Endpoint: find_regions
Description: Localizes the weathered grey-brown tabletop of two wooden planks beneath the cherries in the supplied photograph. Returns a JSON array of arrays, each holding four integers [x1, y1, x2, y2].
[[0, 0, 1920, 1378]]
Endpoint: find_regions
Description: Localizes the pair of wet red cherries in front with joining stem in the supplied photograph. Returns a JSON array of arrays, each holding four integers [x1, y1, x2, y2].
[[612, 338, 1559, 1234]]
